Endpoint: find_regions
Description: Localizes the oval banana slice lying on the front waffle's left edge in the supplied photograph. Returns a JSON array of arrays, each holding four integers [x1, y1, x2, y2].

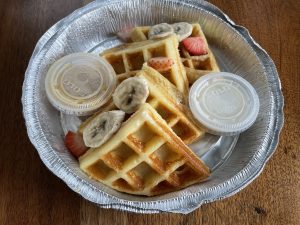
[[83, 110, 125, 148]]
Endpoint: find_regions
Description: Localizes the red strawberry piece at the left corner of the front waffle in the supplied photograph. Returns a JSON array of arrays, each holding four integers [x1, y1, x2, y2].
[[65, 131, 88, 158]]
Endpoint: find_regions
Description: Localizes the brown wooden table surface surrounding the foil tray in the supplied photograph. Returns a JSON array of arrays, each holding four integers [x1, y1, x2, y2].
[[0, 0, 300, 225]]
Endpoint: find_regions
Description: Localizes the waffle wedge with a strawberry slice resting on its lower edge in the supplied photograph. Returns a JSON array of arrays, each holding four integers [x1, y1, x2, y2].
[[100, 35, 189, 95]]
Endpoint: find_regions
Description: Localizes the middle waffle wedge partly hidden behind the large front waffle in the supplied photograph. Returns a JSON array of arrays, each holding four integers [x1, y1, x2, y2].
[[79, 64, 204, 144]]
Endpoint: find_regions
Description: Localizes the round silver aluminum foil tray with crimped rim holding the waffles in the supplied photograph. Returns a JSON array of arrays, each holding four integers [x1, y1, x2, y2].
[[22, 0, 283, 213]]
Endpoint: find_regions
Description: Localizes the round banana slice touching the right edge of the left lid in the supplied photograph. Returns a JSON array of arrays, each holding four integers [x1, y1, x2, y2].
[[113, 77, 149, 113]]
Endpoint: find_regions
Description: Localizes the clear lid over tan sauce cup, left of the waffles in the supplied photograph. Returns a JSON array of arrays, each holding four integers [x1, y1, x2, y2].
[[45, 53, 116, 116]]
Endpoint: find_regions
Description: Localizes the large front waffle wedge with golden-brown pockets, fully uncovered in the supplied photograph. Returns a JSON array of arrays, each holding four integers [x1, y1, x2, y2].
[[79, 103, 209, 196]]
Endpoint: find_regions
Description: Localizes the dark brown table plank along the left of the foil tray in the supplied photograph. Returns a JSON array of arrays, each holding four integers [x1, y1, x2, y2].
[[0, 0, 81, 225]]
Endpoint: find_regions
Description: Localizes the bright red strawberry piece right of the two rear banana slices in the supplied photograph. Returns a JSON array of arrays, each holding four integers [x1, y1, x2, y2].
[[182, 37, 208, 55]]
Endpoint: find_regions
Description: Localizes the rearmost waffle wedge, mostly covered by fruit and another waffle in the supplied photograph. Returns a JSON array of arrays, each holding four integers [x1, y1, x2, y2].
[[131, 23, 220, 84]]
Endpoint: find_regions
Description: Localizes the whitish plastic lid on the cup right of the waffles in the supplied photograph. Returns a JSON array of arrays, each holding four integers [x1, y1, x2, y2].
[[189, 72, 259, 136]]
